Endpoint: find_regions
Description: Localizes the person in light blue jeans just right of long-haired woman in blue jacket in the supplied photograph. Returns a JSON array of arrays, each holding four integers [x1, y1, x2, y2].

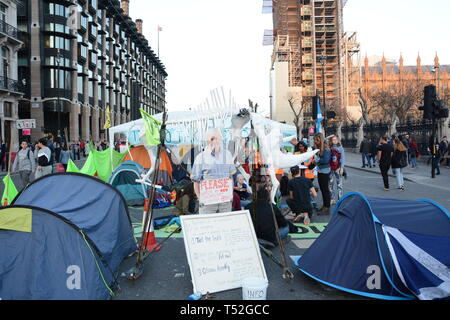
[[330, 136, 345, 204]]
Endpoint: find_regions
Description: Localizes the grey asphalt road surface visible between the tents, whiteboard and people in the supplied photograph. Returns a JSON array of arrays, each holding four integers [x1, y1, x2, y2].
[[0, 152, 450, 300]]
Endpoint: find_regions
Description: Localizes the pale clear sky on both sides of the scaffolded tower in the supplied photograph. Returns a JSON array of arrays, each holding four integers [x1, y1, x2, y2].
[[130, 0, 450, 113]]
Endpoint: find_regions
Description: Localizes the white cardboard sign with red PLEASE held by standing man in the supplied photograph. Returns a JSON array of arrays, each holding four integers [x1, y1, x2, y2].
[[200, 178, 233, 205]]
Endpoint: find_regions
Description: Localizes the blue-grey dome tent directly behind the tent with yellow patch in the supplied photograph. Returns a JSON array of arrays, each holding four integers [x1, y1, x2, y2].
[[13, 173, 136, 294]]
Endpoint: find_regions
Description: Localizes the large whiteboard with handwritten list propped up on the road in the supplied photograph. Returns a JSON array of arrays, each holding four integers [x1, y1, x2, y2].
[[180, 211, 267, 294]]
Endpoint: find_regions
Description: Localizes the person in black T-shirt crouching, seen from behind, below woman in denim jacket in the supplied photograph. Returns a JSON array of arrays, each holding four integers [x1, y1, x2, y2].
[[286, 166, 317, 226]]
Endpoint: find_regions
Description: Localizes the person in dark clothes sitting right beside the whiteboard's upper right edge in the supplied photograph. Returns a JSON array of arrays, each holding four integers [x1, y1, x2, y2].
[[245, 185, 289, 245]]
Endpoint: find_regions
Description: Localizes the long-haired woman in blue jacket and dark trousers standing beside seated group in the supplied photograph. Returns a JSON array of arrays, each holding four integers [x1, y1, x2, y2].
[[314, 133, 331, 215]]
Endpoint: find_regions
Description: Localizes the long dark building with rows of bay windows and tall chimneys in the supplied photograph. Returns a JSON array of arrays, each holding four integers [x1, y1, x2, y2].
[[18, 0, 167, 141]]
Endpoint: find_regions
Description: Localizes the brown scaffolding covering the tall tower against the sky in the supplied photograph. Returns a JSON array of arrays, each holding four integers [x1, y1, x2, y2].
[[272, 0, 345, 117]]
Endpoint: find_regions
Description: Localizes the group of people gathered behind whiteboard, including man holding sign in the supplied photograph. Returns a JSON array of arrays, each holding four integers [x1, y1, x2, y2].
[[170, 130, 346, 243]]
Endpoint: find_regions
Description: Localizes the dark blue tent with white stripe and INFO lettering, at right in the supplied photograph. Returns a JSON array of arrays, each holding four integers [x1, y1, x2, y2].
[[297, 193, 450, 300]]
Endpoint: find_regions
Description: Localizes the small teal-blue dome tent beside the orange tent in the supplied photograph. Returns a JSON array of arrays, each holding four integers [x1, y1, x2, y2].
[[109, 161, 148, 206]]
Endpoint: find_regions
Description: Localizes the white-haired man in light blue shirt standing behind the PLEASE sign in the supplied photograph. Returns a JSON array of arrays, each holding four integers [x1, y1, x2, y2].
[[192, 129, 236, 214]]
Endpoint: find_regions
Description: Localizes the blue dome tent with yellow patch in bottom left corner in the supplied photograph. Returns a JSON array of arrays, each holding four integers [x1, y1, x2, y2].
[[0, 206, 114, 300]]
